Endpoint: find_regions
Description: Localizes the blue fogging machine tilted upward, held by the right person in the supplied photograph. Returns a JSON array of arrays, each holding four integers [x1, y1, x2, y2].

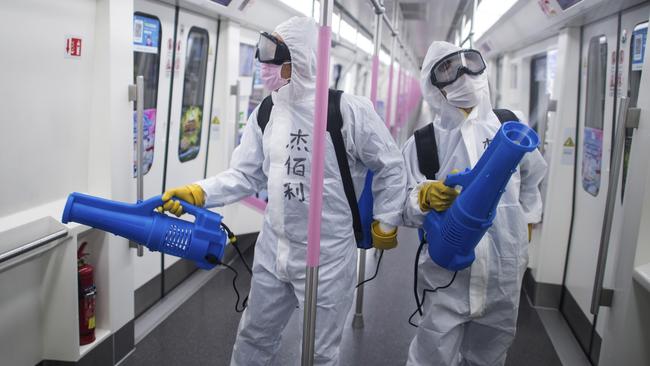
[[423, 122, 539, 271]]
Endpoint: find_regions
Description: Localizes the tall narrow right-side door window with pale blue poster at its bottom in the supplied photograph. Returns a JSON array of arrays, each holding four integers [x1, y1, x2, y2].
[[582, 36, 607, 196]]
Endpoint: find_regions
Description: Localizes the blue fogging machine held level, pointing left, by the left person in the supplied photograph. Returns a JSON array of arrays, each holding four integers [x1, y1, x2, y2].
[[61, 192, 228, 269]]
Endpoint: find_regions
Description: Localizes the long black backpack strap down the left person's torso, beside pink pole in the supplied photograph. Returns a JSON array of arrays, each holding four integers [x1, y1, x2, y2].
[[327, 89, 363, 242]]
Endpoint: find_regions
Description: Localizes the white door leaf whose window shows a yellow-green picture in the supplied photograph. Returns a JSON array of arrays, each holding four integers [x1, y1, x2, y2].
[[163, 9, 218, 293]]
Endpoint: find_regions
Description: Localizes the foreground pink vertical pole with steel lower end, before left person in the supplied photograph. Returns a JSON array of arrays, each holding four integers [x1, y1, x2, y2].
[[301, 0, 333, 366]]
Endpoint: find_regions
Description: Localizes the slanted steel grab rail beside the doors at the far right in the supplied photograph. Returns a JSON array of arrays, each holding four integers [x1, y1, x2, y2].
[[590, 97, 630, 315]]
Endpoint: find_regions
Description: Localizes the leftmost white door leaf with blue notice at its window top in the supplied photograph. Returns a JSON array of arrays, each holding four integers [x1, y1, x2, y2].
[[132, 0, 174, 315]]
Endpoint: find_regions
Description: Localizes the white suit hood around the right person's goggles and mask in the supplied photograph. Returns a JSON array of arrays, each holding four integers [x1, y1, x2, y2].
[[420, 42, 498, 128]]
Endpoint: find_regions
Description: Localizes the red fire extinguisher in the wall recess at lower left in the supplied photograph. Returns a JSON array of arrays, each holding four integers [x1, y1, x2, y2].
[[77, 242, 97, 345]]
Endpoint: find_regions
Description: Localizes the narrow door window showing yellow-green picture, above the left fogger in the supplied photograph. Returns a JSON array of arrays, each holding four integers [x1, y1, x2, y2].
[[178, 27, 208, 163]]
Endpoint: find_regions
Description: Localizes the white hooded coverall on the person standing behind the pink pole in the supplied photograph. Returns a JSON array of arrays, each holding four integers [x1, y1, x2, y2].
[[198, 17, 406, 366]]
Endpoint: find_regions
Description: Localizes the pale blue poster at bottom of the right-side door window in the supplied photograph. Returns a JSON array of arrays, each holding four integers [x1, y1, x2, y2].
[[582, 127, 603, 197]]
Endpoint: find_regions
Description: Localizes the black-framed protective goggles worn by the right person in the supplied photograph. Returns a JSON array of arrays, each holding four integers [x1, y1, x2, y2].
[[431, 50, 485, 89]]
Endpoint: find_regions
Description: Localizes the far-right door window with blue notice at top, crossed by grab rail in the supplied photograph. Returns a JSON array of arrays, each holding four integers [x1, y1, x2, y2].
[[621, 22, 648, 200]]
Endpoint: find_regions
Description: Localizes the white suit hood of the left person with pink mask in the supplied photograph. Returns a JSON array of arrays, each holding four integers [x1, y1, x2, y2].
[[275, 17, 318, 100]]
